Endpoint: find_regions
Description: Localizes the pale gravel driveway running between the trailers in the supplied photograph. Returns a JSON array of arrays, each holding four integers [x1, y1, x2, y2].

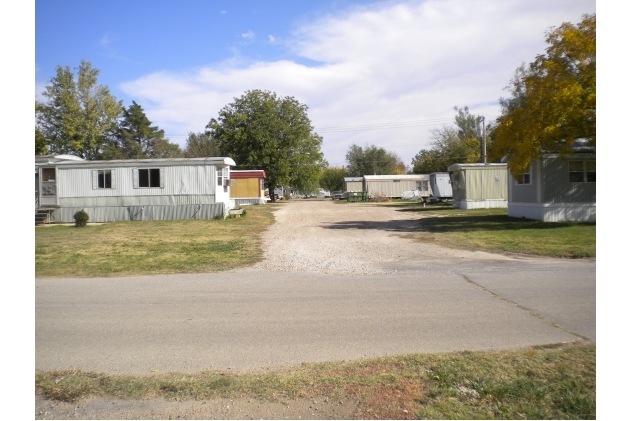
[[255, 200, 515, 275]]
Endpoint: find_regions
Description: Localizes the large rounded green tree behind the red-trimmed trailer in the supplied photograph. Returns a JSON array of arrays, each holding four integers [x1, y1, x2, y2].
[[206, 90, 326, 201]]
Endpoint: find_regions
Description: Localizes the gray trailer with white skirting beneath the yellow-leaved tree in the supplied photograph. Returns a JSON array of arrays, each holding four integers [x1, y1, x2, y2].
[[508, 147, 596, 222]]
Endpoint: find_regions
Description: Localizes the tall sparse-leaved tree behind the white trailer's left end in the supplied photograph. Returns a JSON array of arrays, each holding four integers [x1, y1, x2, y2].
[[35, 60, 122, 159]]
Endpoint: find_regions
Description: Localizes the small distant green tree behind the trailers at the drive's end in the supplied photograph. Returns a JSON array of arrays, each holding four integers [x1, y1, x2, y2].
[[346, 144, 405, 177]]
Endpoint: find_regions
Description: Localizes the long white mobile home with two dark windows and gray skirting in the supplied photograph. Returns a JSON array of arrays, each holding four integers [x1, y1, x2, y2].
[[35, 156, 235, 222]]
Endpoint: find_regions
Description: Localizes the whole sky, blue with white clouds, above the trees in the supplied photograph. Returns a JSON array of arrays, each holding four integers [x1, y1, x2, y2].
[[35, 0, 596, 165]]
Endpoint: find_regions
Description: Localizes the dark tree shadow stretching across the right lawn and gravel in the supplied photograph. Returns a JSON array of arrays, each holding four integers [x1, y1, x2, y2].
[[322, 213, 594, 233]]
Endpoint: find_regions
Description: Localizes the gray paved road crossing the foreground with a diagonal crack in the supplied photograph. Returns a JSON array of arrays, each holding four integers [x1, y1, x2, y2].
[[35, 202, 596, 373]]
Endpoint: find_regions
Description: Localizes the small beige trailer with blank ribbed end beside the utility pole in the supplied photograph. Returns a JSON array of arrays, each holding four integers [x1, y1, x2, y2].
[[448, 164, 508, 209]]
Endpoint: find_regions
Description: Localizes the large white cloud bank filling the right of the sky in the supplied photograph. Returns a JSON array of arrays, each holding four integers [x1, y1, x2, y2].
[[122, 0, 596, 165]]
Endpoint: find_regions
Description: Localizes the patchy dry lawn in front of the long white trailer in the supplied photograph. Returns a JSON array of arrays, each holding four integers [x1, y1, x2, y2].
[[35, 205, 279, 277]]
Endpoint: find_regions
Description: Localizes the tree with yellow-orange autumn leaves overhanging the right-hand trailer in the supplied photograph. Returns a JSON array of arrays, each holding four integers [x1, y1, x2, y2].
[[490, 14, 596, 175]]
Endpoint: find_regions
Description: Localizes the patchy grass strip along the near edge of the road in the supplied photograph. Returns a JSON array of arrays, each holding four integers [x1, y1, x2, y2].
[[35, 343, 596, 419]]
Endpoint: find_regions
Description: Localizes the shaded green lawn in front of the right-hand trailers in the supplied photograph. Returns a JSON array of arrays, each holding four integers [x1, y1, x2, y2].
[[382, 202, 596, 258]]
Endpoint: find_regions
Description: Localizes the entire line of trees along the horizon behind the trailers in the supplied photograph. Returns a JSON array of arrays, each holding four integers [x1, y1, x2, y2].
[[35, 14, 596, 197]]
